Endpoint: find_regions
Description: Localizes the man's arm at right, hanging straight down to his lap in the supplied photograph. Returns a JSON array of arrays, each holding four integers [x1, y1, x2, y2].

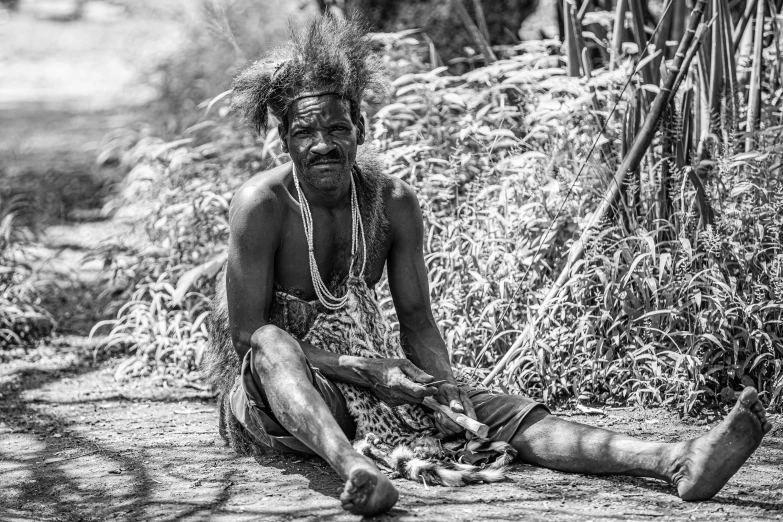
[[387, 181, 475, 433]]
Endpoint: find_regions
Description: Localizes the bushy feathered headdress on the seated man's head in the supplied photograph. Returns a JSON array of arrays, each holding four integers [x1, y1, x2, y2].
[[231, 15, 387, 134]]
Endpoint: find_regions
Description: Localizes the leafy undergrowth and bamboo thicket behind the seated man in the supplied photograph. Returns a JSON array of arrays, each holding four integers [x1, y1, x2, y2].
[[1, 0, 783, 413]]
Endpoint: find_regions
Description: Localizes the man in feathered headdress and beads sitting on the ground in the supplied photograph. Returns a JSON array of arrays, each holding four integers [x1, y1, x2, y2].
[[208, 17, 771, 515]]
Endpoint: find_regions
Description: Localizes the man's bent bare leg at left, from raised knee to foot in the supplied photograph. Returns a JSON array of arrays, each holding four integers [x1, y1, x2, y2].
[[253, 326, 399, 515]]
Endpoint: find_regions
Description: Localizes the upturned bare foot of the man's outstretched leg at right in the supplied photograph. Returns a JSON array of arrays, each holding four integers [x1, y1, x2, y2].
[[672, 388, 772, 500]]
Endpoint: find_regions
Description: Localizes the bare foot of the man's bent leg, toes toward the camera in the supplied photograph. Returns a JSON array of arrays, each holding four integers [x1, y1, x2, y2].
[[340, 460, 399, 516]]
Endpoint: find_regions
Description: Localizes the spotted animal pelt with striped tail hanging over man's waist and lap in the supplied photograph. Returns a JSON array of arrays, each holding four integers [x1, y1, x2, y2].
[[303, 277, 516, 486]]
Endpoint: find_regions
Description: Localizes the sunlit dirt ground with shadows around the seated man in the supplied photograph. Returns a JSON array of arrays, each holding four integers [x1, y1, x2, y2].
[[0, 336, 783, 522]]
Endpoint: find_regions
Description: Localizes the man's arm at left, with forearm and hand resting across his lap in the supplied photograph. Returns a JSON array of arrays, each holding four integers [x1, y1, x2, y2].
[[226, 181, 435, 404]]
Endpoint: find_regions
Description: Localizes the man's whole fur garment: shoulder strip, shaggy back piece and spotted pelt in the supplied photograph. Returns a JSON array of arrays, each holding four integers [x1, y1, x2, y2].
[[202, 150, 516, 486]]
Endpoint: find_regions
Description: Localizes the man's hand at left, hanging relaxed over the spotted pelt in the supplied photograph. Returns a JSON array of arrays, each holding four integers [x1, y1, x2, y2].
[[358, 359, 438, 406]]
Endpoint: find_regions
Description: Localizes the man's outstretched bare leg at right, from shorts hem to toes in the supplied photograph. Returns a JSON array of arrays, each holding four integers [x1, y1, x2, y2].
[[511, 388, 772, 500]]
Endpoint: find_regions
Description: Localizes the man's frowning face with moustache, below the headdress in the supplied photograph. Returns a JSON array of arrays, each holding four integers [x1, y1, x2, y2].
[[279, 94, 364, 192]]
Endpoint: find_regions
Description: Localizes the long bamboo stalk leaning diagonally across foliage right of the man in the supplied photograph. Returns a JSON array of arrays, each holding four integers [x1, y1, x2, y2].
[[482, 0, 707, 385]]
